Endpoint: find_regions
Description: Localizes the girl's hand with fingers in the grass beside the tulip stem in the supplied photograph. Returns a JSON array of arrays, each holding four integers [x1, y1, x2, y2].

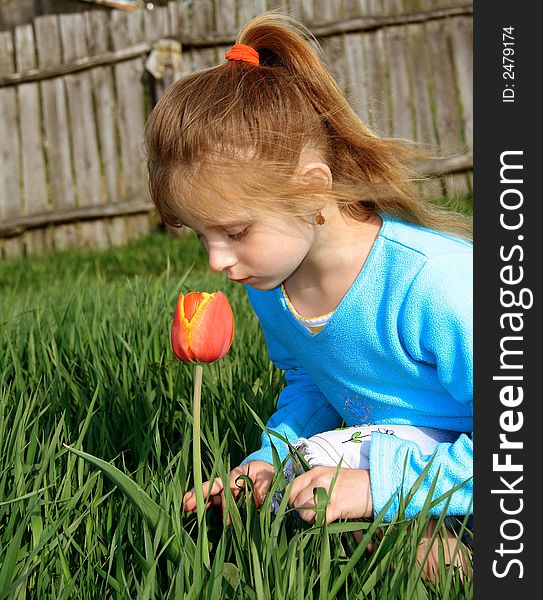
[[183, 460, 275, 525]]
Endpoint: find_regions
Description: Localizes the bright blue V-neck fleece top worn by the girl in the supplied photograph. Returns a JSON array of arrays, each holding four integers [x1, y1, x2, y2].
[[243, 215, 473, 521]]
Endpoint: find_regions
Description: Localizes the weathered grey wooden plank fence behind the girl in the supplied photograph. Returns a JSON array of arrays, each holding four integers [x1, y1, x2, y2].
[[0, 0, 473, 257]]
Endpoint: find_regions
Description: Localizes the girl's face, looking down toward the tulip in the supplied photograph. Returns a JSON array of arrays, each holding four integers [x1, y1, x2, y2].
[[179, 212, 315, 290]]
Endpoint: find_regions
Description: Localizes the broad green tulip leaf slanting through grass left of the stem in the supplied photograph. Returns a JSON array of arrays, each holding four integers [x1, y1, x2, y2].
[[64, 444, 180, 563]]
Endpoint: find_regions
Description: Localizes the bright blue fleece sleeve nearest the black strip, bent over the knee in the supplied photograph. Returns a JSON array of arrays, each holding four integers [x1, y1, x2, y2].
[[370, 252, 473, 521]]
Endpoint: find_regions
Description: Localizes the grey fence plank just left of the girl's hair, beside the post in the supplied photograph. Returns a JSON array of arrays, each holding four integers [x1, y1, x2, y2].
[[110, 11, 147, 200]]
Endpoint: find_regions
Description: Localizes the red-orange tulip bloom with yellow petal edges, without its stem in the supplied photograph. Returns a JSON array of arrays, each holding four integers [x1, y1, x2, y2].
[[172, 292, 234, 363]]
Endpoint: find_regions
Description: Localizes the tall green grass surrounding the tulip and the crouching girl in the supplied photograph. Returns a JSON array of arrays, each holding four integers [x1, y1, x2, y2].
[[0, 227, 472, 600]]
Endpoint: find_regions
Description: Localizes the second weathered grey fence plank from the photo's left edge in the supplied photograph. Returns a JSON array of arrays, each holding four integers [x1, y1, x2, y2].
[[15, 24, 48, 214]]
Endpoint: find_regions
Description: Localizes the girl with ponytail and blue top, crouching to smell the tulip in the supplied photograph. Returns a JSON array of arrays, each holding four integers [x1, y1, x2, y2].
[[146, 13, 472, 572]]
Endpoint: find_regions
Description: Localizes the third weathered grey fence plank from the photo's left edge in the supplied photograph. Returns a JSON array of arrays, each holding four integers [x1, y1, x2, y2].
[[35, 15, 74, 209]]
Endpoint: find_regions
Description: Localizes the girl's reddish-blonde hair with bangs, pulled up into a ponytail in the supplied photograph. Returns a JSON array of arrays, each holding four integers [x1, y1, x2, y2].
[[145, 12, 470, 237]]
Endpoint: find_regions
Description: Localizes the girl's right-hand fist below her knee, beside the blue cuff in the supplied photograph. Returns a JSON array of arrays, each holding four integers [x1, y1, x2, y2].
[[288, 467, 373, 523]]
